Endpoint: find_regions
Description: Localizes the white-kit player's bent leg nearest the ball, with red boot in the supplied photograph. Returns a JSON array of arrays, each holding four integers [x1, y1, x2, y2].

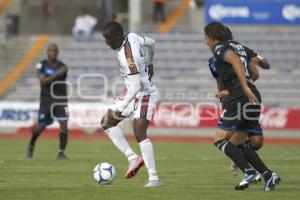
[[101, 110, 144, 179]]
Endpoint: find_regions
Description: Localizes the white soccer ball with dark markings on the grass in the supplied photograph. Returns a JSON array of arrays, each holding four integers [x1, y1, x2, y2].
[[93, 162, 116, 185]]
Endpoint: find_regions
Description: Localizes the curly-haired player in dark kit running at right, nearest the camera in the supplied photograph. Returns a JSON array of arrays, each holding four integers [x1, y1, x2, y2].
[[204, 22, 280, 191]]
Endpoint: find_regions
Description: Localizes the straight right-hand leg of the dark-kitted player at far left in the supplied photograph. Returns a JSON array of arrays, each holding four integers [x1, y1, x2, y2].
[[57, 120, 69, 160]]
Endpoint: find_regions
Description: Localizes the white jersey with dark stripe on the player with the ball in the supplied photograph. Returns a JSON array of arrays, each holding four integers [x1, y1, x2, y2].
[[117, 33, 157, 93]]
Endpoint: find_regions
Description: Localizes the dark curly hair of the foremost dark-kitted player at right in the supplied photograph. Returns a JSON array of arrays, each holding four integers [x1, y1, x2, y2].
[[204, 22, 232, 42]]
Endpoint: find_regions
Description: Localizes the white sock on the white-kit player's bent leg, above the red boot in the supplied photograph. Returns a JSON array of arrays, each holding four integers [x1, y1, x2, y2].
[[105, 126, 138, 161]]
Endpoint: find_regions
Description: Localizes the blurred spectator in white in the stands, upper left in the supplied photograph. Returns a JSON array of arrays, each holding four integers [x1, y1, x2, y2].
[[72, 10, 98, 41]]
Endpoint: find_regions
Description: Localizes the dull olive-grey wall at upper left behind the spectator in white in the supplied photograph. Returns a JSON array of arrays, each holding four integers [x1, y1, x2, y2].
[[20, 0, 102, 34]]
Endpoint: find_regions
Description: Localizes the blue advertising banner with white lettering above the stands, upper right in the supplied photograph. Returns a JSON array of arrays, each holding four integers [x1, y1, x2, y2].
[[205, 0, 300, 25]]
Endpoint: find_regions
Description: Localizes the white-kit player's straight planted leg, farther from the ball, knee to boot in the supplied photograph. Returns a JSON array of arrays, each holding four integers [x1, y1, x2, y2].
[[133, 118, 161, 187]]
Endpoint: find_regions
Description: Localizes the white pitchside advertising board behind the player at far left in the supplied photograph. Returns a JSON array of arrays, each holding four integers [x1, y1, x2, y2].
[[0, 102, 108, 129]]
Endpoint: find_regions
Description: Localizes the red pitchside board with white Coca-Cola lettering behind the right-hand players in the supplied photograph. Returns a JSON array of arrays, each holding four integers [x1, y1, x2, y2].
[[152, 105, 300, 129]]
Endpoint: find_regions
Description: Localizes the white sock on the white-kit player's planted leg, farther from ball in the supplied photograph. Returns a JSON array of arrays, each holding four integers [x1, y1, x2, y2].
[[139, 139, 158, 180]]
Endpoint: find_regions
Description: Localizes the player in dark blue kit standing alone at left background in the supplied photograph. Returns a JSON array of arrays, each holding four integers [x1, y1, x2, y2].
[[26, 44, 68, 160]]
